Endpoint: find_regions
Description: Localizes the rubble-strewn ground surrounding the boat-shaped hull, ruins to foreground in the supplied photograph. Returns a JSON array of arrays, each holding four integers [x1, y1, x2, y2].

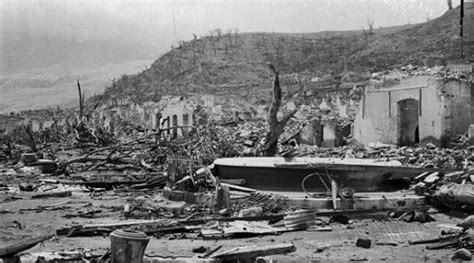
[[0, 102, 473, 262]]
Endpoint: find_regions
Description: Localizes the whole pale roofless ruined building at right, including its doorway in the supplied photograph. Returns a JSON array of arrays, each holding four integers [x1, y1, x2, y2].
[[353, 74, 474, 146]]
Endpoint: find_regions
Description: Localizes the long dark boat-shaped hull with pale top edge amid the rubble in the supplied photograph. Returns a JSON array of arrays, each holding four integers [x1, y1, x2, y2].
[[214, 157, 442, 192]]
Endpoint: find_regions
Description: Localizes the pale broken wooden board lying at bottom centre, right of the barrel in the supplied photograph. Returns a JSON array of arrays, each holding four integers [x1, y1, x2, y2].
[[212, 244, 296, 261]]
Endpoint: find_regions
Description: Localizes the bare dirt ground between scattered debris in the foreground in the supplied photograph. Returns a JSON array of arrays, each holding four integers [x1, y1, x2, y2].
[[0, 168, 461, 262]]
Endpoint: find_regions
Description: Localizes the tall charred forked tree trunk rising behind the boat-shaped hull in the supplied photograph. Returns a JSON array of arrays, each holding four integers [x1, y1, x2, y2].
[[262, 64, 296, 156]]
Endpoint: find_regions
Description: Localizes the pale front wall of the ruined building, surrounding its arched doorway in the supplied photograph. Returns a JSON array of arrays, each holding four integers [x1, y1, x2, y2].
[[354, 76, 444, 144]]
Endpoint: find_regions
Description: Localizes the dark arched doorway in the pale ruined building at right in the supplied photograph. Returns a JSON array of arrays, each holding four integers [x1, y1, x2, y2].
[[398, 99, 420, 146]]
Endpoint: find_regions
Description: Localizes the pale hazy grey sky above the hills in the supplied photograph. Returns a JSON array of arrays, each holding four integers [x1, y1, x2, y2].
[[0, 0, 459, 48]]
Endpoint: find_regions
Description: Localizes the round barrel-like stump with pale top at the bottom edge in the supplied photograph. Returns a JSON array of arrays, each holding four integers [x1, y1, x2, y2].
[[110, 230, 150, 263]]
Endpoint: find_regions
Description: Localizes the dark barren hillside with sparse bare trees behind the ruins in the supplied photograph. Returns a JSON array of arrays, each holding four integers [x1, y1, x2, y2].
[[96, 3, 474, 104]]
